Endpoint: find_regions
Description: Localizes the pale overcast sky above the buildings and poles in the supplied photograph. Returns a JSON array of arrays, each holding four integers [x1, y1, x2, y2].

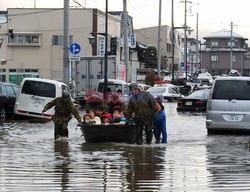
[[0, 0, 250, 39]]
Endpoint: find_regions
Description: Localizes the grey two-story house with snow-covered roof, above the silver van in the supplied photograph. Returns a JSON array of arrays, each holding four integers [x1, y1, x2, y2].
[[200, 29, 250, 75]]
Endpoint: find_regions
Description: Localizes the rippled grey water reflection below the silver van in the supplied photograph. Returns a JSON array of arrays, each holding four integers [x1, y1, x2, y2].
[[206, 135, 250, 191]]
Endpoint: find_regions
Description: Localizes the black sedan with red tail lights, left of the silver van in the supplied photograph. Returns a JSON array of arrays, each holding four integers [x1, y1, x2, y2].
[[177, 89, 210, 112]]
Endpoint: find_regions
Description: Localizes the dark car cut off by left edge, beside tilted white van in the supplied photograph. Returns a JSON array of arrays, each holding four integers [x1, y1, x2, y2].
[[0, 82, 19, 119]]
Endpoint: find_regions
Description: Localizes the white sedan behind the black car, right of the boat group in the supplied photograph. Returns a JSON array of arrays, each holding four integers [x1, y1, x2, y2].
[[147, 84, 184, 101]]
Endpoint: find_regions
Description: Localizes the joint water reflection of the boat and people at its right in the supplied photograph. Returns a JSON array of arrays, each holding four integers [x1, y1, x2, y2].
[[82, 144, 166, 191]]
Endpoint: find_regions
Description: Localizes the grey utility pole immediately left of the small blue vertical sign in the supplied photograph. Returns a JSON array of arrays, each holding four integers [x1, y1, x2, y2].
[[123, 0, 131, 82]]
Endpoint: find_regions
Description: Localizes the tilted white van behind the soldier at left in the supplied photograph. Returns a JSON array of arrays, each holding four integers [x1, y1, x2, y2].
[[14, 78, 68, 119]]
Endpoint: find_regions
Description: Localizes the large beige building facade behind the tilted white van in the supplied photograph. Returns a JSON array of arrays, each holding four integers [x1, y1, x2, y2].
[[0, 8, 121, 84]]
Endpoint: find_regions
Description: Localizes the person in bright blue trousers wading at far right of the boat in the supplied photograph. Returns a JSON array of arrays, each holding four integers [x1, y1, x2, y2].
[[154, 96, 167, 143]]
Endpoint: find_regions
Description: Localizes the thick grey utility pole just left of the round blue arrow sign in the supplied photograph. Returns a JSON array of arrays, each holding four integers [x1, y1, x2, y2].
[[63, 0, 69, 86]]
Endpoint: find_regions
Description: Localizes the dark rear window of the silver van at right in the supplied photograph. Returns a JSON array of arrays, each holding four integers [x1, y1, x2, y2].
[[212, 80, 250, 100]]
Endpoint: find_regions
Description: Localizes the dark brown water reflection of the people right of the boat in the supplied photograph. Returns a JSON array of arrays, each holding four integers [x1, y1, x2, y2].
[[125, 147, 166, 191]]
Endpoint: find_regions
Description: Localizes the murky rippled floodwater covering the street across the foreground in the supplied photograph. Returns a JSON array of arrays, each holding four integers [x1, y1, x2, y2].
[[0, 103, 250, 192]]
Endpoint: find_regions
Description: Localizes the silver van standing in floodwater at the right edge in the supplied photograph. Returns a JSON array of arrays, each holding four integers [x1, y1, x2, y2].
[[206, 77, 250, 133]]
